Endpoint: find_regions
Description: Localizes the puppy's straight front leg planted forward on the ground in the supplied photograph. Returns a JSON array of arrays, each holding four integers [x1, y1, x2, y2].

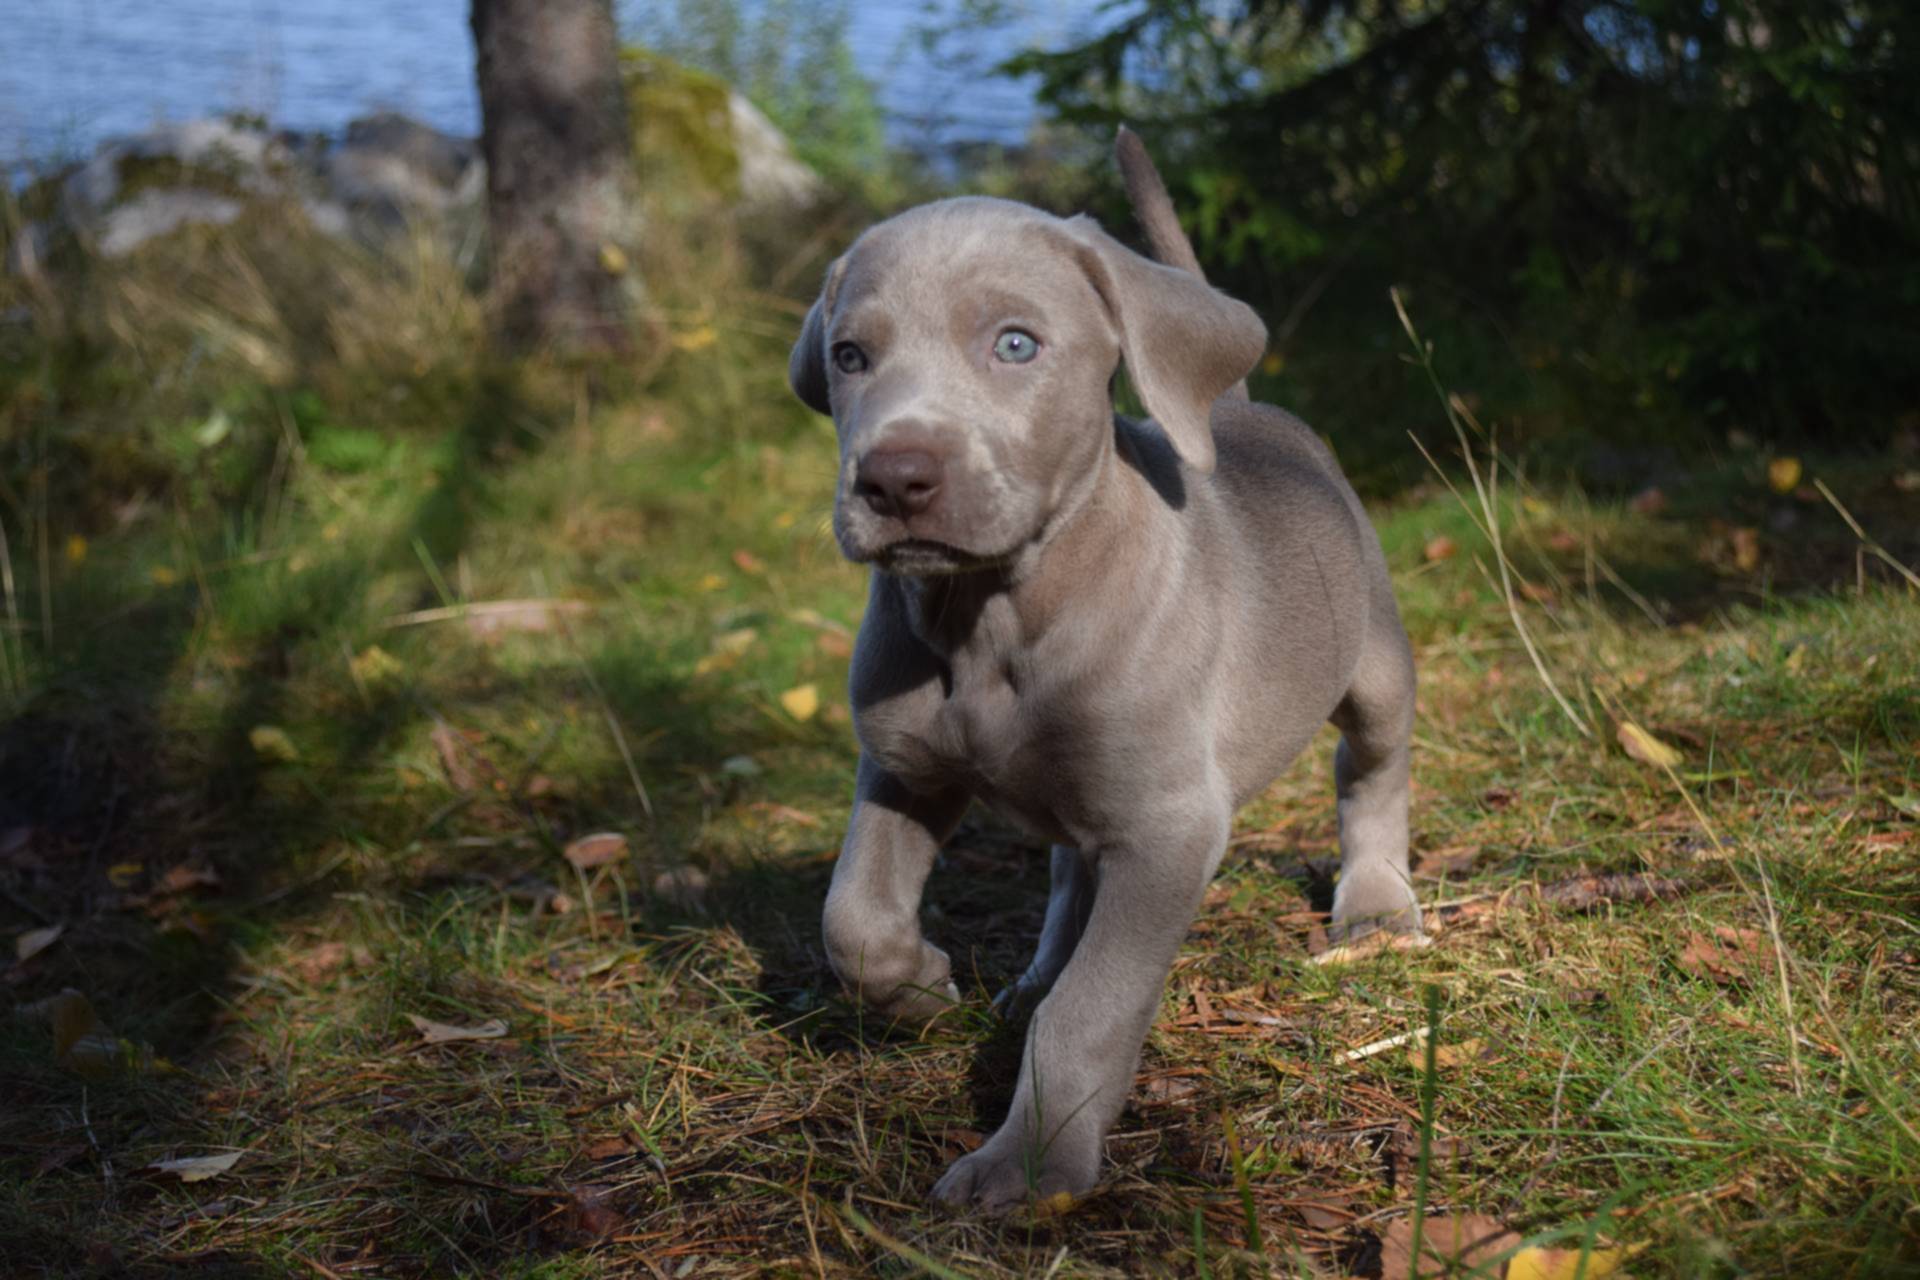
[[933, 804, 1229, 1213]]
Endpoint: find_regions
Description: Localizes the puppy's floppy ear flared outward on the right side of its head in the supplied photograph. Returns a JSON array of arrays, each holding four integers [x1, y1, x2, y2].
[[1068, 217, 1267, 472]]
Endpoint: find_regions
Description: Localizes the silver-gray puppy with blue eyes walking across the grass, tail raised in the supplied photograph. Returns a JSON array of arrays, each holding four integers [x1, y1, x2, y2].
[[789, 130, 1421, 1211]]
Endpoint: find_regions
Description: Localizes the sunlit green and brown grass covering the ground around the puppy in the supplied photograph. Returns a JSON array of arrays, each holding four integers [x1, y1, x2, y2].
[[0, 205, 1920, 1276]]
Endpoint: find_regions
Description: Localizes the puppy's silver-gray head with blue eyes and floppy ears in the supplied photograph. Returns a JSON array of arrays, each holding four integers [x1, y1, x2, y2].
[[789, 198, 1265, 574]]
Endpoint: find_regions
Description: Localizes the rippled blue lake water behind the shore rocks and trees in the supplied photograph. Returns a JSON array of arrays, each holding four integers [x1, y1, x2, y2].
[[0, 0, 1100, 165]]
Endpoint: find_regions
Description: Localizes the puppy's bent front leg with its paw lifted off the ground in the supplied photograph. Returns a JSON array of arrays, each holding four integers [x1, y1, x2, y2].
[[824, 756, 968, 1021]]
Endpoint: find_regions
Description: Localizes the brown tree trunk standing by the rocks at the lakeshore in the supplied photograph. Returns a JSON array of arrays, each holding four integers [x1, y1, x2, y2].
[[472, 0, 639, 353]]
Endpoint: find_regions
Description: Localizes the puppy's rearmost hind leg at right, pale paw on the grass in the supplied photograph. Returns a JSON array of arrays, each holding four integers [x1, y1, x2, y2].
[[1327, 610, 1421, 942]]
